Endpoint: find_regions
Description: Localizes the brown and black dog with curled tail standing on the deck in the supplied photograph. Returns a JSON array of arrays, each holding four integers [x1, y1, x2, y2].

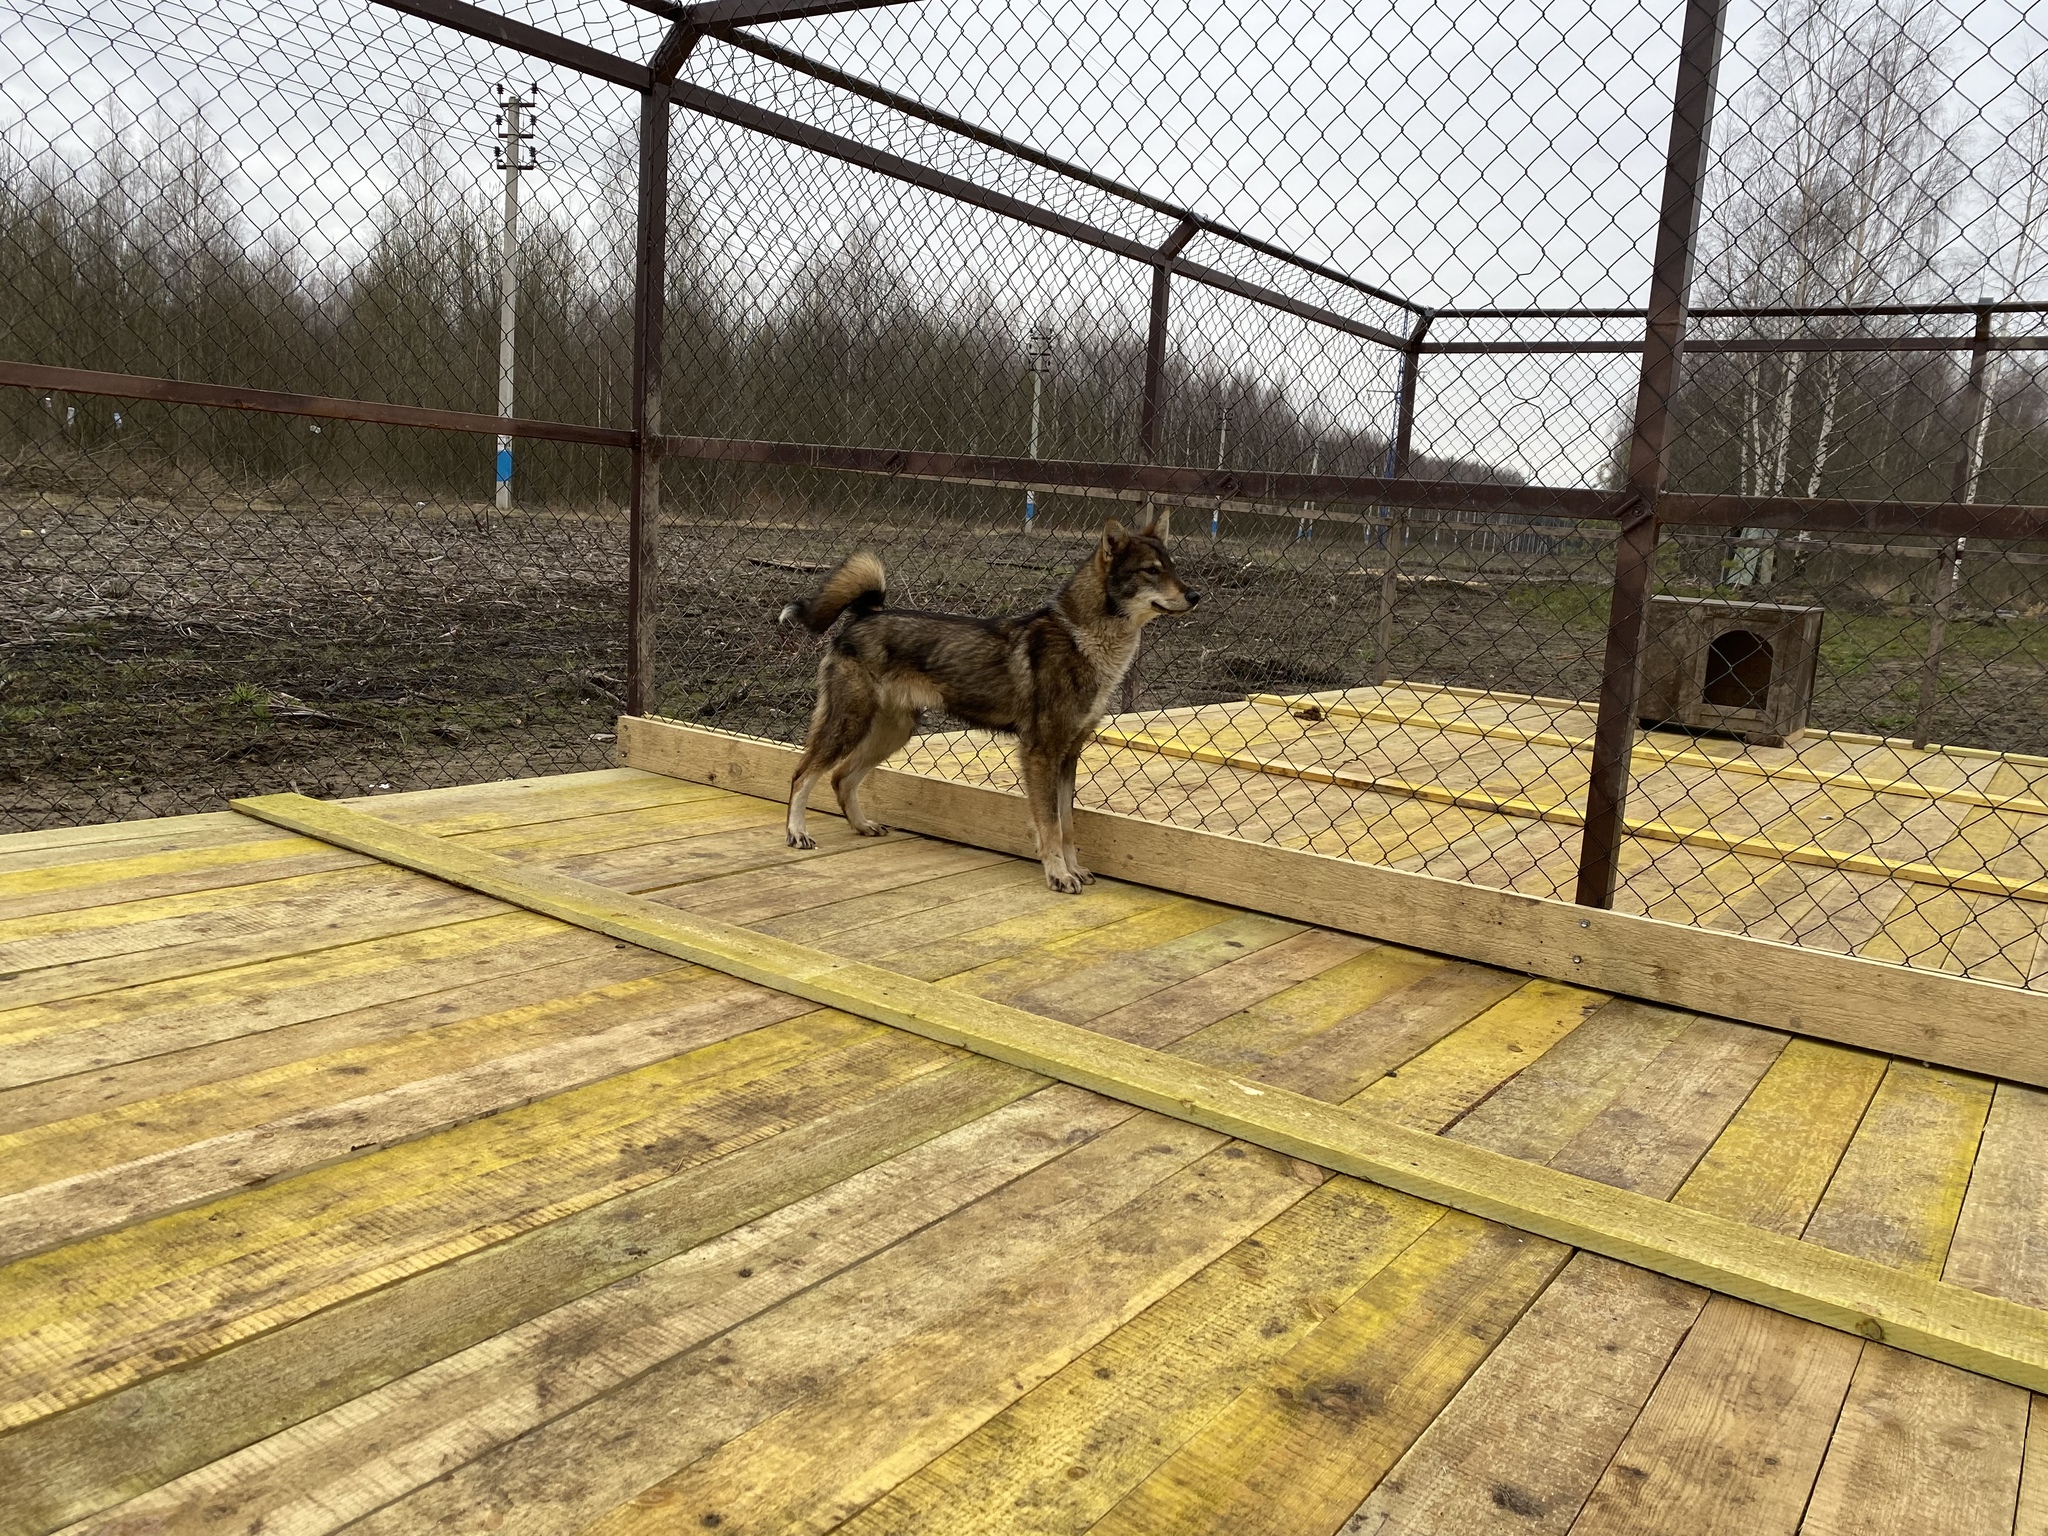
[[782, 522, 1200, 893]]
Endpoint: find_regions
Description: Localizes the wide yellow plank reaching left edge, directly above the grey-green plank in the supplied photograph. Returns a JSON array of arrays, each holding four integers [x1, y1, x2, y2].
[[0, 1012, 946, 1427]]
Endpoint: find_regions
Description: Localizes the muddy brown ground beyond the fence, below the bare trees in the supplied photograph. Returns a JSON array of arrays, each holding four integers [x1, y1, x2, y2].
[[0, 492, 2048, 829]]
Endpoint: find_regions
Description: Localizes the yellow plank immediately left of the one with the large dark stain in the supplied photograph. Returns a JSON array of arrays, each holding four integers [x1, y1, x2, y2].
[[827, 1178, 1440, 1536]]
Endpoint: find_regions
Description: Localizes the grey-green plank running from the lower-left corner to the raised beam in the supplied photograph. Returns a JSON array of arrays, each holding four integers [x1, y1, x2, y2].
[[0, 1057, 1044, 1536]]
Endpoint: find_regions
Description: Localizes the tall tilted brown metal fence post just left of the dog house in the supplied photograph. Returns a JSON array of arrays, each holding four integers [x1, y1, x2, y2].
[[1577, 0, 1724, 907]]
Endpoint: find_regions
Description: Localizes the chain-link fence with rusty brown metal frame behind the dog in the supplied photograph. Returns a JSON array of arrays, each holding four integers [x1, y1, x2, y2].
[[0, 0, 2048, 985]]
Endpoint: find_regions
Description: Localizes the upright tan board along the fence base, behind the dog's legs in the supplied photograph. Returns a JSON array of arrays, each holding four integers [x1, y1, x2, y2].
[[621, 719, 2048, 1085]]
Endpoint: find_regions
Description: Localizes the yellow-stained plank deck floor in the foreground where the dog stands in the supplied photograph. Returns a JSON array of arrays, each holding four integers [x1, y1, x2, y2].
[[0, 770, 2048, 1536]]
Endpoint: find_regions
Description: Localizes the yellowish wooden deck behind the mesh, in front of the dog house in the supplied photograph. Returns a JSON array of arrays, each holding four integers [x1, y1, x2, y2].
[[907, 684, 2048, 987]]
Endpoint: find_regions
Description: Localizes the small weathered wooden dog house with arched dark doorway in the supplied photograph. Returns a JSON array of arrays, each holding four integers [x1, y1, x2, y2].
[[1638, 598, 1825, 748]]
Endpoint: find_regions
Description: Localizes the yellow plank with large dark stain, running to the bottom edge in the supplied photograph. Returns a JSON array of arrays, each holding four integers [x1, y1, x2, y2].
[[1092, 1212, 1569, 1536]]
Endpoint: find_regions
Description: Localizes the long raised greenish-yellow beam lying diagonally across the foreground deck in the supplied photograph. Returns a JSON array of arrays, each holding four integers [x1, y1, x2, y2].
[[233, 795, 2048, 1391]]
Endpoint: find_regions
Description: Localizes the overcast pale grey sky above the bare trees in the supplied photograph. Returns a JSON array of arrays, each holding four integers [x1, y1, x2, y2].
[[0, 0, 2048, 481]]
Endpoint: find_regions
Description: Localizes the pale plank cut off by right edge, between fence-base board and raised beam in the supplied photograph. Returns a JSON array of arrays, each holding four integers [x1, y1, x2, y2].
[[1942, 1083, 2048, 1307]]
